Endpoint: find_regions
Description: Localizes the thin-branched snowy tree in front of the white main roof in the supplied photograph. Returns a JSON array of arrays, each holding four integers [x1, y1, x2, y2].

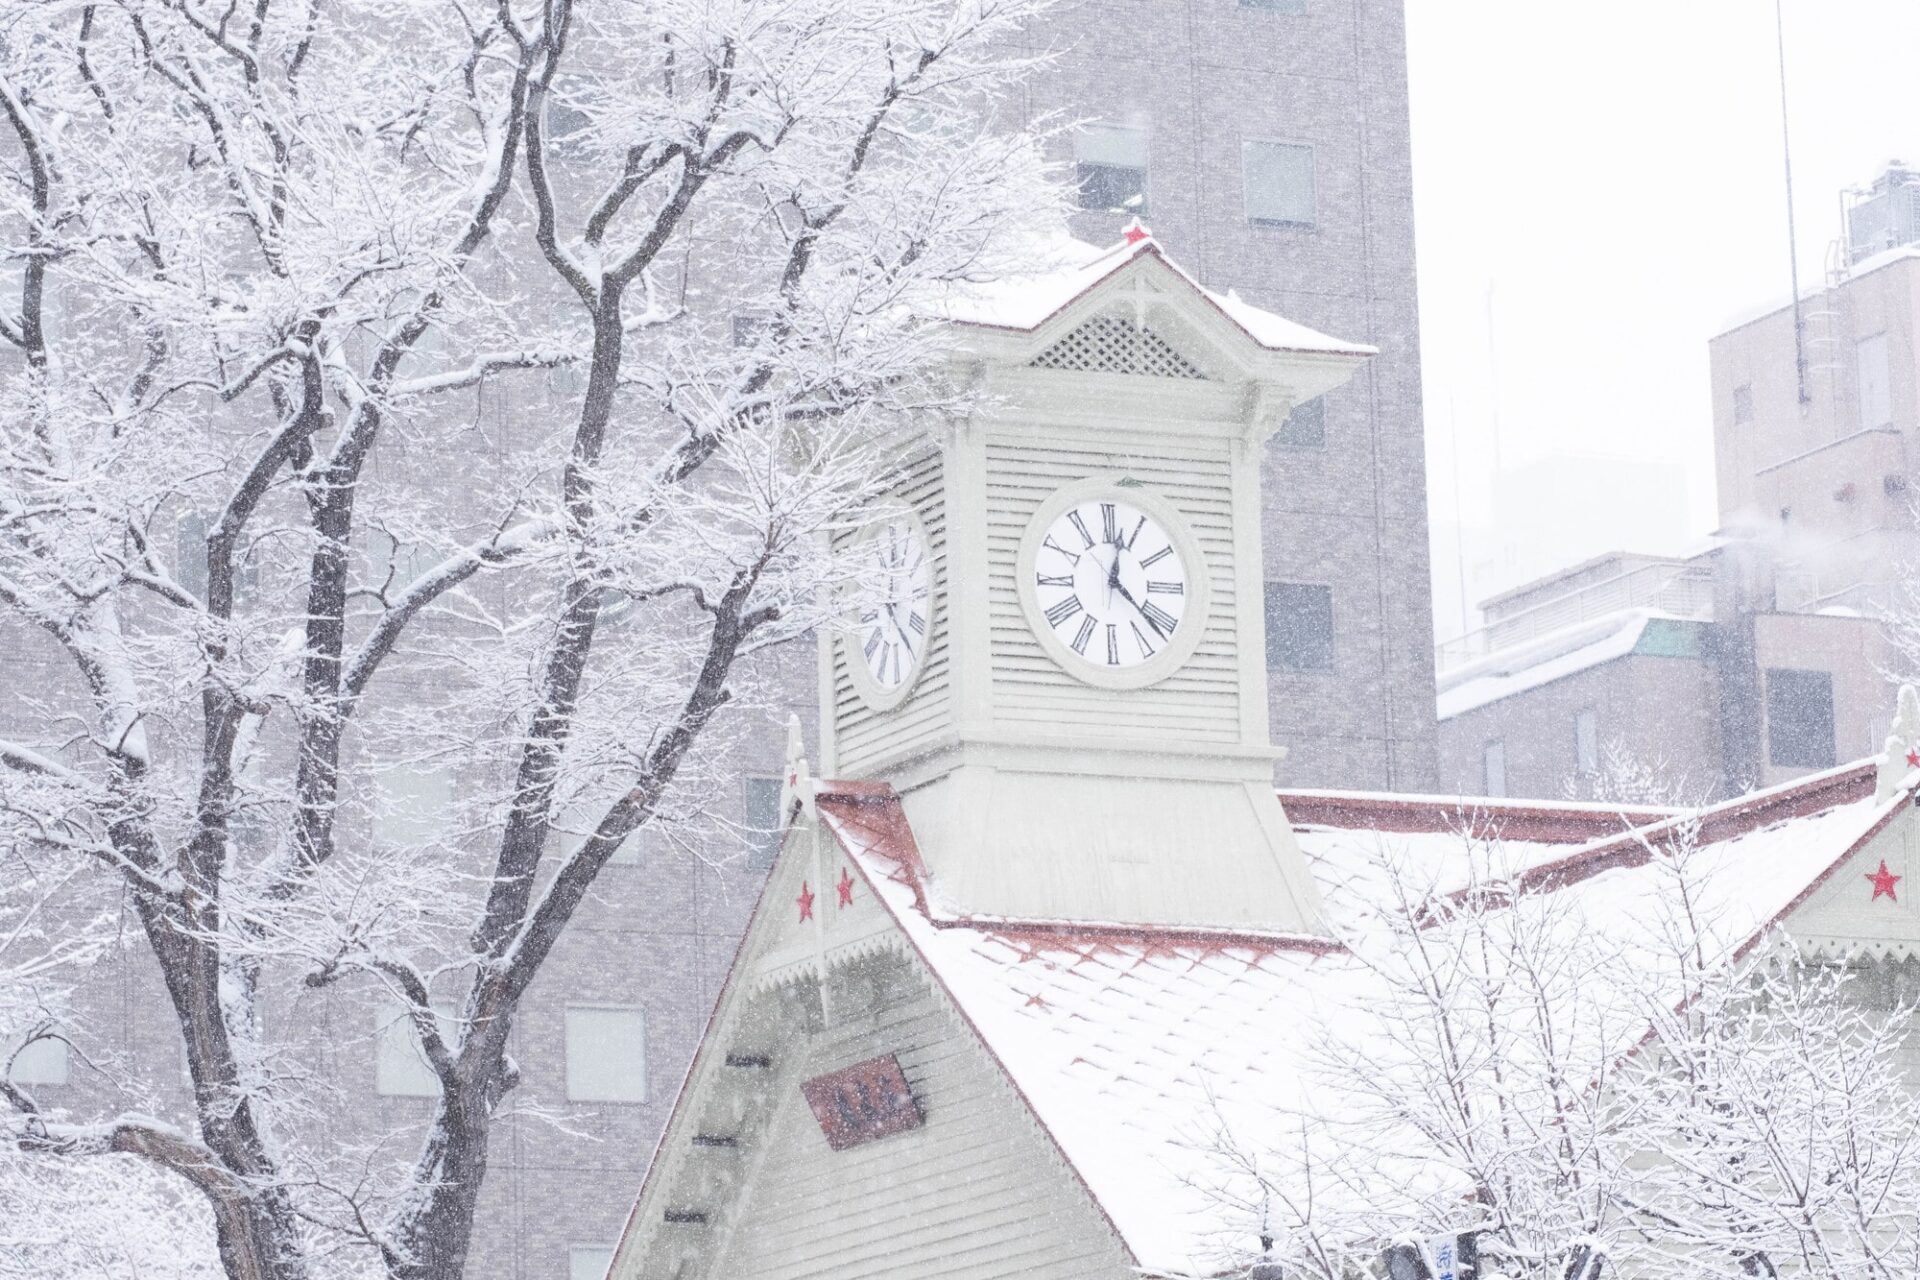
[[1212, 821, 1920, 1280]]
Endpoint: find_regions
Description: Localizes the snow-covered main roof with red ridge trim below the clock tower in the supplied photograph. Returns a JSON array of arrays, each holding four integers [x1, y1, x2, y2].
[[818, 764, 1920, 1276]]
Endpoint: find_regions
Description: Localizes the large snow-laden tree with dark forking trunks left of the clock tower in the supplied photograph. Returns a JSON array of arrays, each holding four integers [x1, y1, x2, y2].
[[0, 0, 1058, 1280]]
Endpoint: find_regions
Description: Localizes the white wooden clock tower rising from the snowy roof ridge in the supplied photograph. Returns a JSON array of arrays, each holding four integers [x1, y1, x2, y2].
[[822, 228, 1373, 933]]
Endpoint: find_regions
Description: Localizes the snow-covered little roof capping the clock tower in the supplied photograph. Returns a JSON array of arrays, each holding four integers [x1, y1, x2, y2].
[[939, 228, 1379, 357]]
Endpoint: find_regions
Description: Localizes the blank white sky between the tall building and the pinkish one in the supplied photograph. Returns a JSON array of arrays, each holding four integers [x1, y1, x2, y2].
[[1407, 0, 1920, 637]]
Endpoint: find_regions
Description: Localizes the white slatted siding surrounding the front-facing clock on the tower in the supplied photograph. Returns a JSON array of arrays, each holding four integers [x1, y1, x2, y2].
[[987, 432, 1240, 743]]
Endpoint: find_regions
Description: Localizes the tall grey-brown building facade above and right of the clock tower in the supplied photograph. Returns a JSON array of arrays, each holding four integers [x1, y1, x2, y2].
[[1027, 0, 1436, 791]]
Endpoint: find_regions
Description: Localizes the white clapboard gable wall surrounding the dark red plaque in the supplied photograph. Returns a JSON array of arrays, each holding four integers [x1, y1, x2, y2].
[[707, 958, 1131, 1280]]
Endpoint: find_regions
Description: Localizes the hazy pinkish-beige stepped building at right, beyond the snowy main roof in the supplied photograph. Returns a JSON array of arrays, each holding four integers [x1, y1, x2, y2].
[[1438, 167, 1920, 796]]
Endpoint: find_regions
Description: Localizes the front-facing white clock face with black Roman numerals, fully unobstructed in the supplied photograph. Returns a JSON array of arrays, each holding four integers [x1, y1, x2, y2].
[[1027, 497, 1188, 670]]
